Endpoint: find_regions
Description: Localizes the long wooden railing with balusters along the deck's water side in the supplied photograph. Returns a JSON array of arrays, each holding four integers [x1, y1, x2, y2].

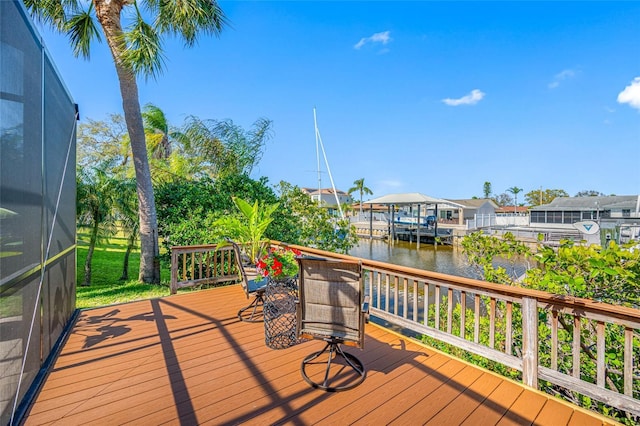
[[276, 243, 640, 416]]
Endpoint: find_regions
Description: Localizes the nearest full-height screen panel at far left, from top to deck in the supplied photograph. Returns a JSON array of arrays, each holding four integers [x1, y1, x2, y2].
[[0, 1, 43, 424]]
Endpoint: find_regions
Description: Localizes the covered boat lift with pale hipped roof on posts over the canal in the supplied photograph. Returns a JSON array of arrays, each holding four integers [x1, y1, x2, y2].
[[362, 192, 464, 248]]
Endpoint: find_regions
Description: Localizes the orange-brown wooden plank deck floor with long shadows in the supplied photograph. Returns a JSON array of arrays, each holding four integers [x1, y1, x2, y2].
[[26, 285, 614, 426]]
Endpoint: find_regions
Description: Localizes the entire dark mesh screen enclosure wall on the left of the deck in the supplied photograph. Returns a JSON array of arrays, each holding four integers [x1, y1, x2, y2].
[[0, 0, 76, 424]]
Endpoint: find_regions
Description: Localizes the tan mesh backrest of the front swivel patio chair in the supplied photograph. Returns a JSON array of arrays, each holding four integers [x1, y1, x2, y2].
[[297, 258, 365, 348]]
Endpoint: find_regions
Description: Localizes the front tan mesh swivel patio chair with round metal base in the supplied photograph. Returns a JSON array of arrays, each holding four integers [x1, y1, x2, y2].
[[296, 258, 369, 392]]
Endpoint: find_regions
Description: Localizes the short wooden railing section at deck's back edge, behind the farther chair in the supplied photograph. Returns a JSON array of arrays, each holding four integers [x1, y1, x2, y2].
[[171, 244, 239, 294]]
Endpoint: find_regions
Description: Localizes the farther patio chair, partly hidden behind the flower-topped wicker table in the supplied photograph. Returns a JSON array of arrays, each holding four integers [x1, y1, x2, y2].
[[226, 238, 267, 322]]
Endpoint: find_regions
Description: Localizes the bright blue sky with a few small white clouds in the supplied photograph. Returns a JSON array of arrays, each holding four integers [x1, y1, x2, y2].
[[41, 1, 640, 199]]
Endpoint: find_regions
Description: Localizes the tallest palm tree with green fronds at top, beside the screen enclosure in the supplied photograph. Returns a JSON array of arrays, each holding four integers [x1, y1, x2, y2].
[[23, 0, 226, 283]]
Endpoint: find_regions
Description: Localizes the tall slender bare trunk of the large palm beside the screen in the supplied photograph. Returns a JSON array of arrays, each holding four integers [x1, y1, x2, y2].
[[94, 0, 160, 283]]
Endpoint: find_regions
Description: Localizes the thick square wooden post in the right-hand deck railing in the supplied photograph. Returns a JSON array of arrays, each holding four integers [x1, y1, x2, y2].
[[522, 296, 538, 389]]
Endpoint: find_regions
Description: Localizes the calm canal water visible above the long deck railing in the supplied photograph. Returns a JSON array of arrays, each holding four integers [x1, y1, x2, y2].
[[349, 238, 478, 278]]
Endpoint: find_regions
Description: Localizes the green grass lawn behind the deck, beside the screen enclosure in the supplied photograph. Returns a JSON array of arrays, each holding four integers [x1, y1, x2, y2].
[[76, 232, 171, 309]]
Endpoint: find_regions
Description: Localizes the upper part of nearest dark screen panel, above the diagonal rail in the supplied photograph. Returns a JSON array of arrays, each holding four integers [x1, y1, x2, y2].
[[0, 1, 42, 279]]
